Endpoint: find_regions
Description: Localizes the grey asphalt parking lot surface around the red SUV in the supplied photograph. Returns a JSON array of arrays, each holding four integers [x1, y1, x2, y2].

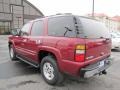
[[0, 36, 120, 90]]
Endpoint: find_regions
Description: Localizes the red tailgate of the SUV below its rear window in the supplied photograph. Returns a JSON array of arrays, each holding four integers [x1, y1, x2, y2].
[[86, 39, 111, 60]]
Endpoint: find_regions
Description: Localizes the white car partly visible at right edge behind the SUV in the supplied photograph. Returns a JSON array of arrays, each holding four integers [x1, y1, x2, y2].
[[111, 32, 120, 50]]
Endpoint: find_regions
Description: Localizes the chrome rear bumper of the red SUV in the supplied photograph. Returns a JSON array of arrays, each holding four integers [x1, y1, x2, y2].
[[80, 57, 113, 78]]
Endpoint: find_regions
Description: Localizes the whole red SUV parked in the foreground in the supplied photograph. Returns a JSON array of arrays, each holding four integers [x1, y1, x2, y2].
[[8, 14, 111, 85]]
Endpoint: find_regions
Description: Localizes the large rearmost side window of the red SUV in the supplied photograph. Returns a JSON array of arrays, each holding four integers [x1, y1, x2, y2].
[[48, 16, 76, 37]]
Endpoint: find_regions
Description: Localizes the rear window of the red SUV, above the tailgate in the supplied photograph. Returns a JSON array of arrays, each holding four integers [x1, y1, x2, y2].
[[79, 17, 110, 38]]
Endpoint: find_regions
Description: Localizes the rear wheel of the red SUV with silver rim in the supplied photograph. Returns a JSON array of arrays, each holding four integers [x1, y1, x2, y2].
[[40, 56, 64, 85]]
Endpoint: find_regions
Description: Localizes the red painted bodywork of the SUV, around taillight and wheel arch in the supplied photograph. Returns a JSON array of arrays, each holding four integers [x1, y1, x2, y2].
[[9, 18, 111, 76]]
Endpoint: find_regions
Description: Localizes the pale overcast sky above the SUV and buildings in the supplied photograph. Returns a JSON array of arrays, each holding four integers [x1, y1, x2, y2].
[[28, 0, 120, 16]]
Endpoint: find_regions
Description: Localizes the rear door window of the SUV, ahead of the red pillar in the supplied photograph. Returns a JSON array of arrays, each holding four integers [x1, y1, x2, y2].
[[31, 21, 44, 36]]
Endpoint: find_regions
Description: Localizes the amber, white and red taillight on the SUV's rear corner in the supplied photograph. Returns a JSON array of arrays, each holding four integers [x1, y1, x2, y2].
[[75, 45, 85, 62]]
